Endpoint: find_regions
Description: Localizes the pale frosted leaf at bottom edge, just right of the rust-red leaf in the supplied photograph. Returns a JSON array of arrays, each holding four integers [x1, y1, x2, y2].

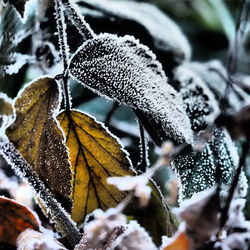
[[17, 229, 67, 250]]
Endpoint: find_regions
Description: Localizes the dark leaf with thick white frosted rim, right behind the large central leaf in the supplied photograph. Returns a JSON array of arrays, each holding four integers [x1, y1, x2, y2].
[[175, 66, 219, 132]]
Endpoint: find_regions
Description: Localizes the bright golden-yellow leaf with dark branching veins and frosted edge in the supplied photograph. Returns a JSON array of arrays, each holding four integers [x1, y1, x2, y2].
[[57, 110, 134, 223]]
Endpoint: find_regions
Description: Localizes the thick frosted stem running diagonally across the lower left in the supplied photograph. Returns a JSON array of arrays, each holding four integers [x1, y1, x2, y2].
[[0, 136, 81, 246]]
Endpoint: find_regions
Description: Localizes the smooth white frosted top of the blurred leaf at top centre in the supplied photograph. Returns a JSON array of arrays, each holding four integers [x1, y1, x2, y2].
[[82, 0, 191, 61]]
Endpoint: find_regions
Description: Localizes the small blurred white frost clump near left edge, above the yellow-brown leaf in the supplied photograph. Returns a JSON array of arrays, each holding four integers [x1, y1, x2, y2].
[[4, 53, 31, 75]]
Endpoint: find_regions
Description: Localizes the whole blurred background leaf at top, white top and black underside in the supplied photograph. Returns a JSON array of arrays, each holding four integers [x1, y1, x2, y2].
[[78, 0, 191, 71]]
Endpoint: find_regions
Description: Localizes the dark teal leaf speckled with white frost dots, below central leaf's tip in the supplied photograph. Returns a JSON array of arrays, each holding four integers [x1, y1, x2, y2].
[[173, 128, 246, 200]]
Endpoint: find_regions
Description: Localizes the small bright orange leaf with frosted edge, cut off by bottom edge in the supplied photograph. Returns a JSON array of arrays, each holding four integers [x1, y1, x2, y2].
[[161, 232, 191, 250]]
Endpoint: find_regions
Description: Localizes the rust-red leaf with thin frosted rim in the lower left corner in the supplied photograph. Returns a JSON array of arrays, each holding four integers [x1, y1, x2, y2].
[[0, 196, 40, 245]]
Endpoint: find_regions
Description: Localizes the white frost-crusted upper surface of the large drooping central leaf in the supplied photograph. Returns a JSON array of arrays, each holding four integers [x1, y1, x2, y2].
[[69, 34, 193, 143]]
